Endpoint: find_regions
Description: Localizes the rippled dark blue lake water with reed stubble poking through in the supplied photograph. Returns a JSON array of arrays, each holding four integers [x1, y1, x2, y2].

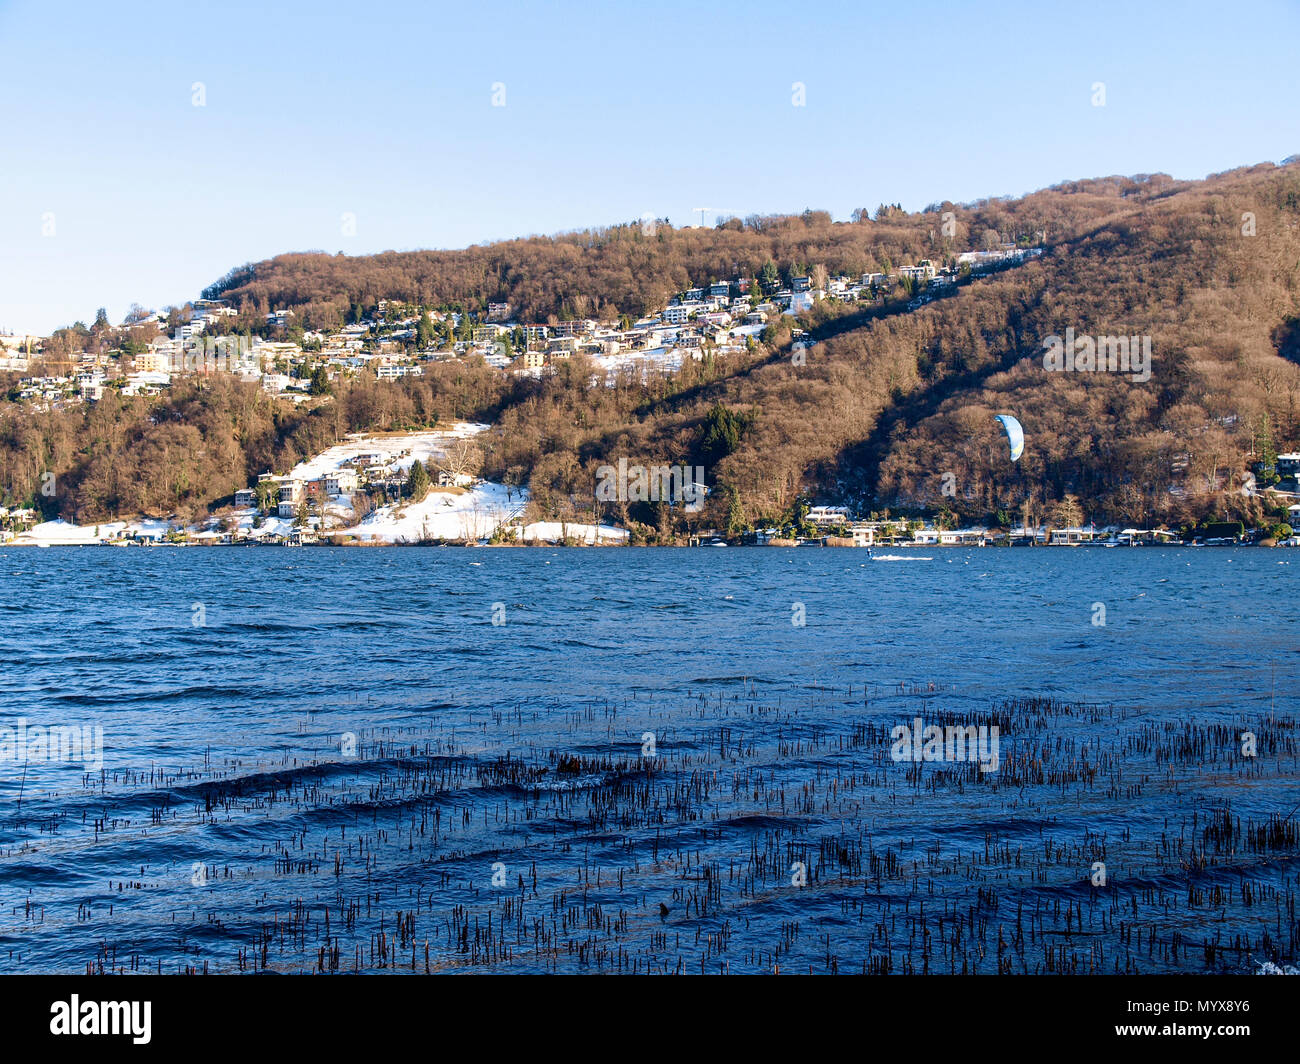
[[0, 548, 1300, 973]]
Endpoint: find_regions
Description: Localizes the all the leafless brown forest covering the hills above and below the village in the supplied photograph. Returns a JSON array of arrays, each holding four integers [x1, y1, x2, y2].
[[0, 164, 1300, 528]]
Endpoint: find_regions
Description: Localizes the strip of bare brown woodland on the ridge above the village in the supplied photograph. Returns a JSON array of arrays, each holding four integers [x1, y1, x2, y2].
[[204, 195, 1076, 329]]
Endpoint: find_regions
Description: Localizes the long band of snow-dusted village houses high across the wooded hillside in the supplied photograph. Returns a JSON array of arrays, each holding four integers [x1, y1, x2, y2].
[[0, 245, 1041, 406]]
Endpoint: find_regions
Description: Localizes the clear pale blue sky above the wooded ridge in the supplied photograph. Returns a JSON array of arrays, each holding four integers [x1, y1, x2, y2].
[[0, 0, 1300, 333]]
